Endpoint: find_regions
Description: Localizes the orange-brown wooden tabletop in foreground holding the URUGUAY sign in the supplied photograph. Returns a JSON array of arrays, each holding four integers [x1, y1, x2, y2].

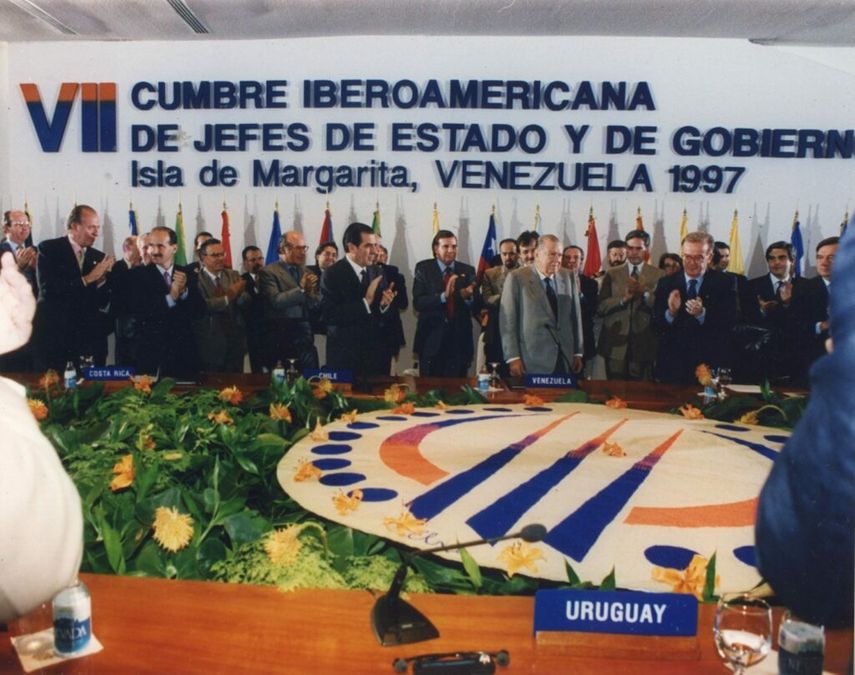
[[0, 574, 852, 675]]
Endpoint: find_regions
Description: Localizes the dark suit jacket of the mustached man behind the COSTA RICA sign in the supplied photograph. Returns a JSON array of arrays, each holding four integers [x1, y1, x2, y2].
[[128, 263, 205, 378]]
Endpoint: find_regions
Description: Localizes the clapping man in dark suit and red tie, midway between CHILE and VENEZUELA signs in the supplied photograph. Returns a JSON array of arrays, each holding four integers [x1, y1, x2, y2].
[[413, 230, 480, 377]]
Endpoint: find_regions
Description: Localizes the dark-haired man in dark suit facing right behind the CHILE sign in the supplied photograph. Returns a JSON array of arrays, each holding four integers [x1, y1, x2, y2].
[[321, 223, 395, 378]]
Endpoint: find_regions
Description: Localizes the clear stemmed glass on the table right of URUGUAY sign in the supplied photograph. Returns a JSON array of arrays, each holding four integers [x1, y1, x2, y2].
[[713, 593, 772, 674]]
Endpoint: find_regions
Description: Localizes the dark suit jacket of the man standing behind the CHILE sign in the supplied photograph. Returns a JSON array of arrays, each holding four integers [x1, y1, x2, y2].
[[321, 258, 391, 377]]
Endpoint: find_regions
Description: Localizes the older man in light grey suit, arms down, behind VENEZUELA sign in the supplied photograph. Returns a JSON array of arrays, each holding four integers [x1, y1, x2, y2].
[[499, 234, 583, 377]]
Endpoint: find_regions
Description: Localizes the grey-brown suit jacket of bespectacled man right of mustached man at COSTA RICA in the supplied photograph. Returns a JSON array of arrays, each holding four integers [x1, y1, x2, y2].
[[193, 269, 250, 373]]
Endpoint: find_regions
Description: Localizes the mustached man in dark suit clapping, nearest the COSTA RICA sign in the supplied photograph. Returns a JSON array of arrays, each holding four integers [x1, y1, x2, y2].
[[128, 226, 205, 379]]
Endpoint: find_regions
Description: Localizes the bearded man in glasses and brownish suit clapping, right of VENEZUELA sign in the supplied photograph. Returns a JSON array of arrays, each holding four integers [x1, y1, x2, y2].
[[597, 230, 664, 380]]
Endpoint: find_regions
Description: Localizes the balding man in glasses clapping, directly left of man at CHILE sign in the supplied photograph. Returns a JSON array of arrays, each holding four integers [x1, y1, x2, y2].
[[259, 230, 321, 370]]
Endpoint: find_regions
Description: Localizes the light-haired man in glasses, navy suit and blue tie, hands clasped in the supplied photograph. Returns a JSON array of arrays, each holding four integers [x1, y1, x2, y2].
[[653, 232, 736, 384]]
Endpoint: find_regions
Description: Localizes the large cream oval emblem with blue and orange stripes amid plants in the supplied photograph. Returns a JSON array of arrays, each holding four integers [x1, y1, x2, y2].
[[278, 403, 787, 593]]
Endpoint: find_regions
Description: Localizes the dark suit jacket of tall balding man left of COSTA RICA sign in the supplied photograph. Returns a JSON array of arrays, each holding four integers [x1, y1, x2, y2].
[[33, 236, 110, 370]]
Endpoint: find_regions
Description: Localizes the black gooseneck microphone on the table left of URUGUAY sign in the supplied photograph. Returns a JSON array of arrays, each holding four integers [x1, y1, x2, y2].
[[371, 523, 547, 647]]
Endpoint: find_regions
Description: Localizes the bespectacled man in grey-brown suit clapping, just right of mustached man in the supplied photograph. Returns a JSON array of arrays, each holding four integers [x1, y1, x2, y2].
[[193, 238, 250, 373]]
